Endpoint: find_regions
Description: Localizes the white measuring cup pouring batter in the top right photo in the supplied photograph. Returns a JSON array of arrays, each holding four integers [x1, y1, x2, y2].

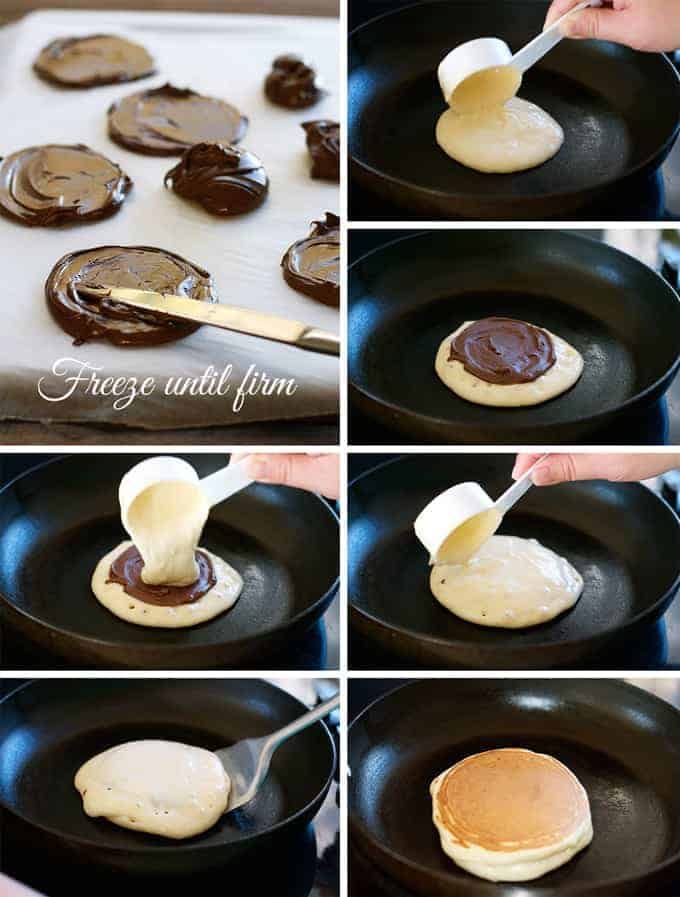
[[437, 0, 602, 112]]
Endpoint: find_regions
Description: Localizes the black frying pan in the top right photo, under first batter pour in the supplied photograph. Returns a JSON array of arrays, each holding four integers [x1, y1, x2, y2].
[[348, 0, 680, 220]]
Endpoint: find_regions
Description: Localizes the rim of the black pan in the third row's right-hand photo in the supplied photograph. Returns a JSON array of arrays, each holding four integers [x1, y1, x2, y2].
[[347, 452, 680, 655]]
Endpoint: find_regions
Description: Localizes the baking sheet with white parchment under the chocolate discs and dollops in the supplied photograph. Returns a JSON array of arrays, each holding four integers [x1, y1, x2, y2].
[[0, 10, 339, 429]]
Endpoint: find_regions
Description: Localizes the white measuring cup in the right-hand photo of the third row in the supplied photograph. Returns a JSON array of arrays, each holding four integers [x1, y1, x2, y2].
[[414, 455, 547, 564]]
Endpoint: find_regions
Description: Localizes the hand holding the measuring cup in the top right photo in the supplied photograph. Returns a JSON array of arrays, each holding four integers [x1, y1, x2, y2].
[[545, 0, 680, 53]]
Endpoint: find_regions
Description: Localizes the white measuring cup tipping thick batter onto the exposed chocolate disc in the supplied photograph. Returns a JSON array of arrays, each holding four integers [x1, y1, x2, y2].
[[118, 455, 253, 532]]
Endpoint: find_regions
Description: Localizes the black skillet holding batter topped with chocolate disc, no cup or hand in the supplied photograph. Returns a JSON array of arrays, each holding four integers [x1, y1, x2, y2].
[[348, 230, 680, 445]]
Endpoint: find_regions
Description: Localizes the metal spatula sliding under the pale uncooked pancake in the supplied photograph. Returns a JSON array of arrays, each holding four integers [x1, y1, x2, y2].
[[215, 694, 340, 813]]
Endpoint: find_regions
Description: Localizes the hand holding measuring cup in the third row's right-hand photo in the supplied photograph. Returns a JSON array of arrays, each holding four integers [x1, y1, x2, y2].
[[512, 452, 680, 486]]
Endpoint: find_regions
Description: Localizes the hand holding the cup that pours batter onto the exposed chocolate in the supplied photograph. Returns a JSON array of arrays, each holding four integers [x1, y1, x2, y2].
[[229, 453, 340, 499]]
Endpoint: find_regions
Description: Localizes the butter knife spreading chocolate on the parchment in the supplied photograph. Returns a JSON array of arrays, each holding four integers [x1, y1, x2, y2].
[[76, 283, 340, 355]]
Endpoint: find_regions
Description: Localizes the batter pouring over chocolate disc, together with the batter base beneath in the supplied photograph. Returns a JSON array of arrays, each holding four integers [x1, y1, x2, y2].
[[92, 480, 243, 628]]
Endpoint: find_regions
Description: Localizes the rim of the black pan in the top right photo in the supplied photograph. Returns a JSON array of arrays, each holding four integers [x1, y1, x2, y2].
[[347, 0, 680, 203]]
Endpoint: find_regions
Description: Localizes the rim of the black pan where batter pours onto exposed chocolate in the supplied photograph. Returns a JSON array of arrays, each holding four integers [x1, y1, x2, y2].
[[0, 452, 340, 655]]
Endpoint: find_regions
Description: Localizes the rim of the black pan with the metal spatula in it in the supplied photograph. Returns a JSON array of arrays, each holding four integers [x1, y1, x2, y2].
[[0, 677, 338, 856]]
